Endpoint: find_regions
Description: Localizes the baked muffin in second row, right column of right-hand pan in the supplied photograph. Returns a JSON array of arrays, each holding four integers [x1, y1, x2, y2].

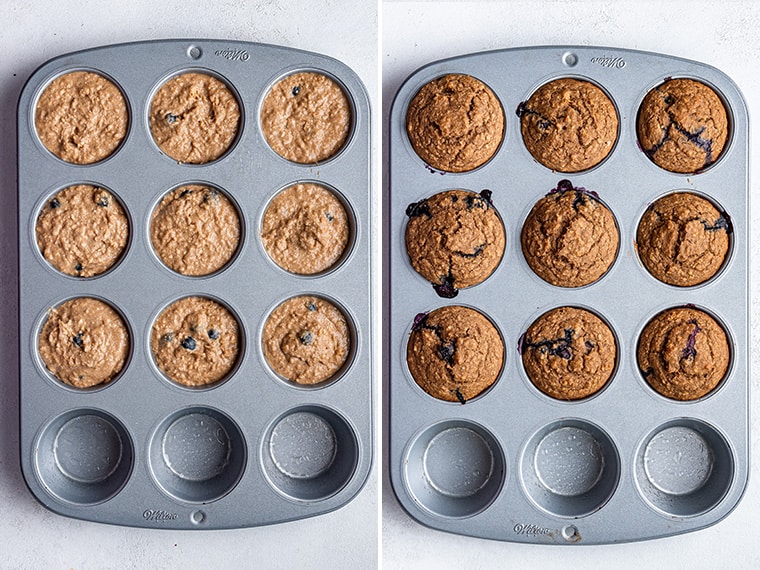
[[636, 192, 731, 287]]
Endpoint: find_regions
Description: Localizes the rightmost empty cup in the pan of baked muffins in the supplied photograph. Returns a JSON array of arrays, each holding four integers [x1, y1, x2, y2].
[[635, 418, 734, 517]]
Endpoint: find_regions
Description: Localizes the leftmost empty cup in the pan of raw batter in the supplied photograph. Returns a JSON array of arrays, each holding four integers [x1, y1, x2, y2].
[[35, 409, 134, 505]]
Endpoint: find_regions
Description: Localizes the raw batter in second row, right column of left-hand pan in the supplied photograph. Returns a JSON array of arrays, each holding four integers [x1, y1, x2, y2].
[[261, 183, 349, 275]]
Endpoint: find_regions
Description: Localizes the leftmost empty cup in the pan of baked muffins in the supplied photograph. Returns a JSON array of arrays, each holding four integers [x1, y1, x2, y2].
[[403, 420, 507, 518]]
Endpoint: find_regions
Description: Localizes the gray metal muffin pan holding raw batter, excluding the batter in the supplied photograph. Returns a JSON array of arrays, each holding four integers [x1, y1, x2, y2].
[[18, 40, 373, 529]]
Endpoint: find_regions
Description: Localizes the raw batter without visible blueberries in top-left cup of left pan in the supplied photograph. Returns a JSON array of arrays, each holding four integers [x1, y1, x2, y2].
[[34, 71, 129, 164]]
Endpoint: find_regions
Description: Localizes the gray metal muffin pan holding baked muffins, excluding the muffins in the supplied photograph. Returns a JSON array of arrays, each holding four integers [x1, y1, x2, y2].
[[388, 46, 749, 544]]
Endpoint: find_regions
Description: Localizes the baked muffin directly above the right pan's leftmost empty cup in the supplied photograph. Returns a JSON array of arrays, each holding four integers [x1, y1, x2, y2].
[[406, 305, 504, 404]]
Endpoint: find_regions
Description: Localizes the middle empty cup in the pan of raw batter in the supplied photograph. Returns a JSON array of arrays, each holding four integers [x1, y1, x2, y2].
[[149, 406, 247, 503]]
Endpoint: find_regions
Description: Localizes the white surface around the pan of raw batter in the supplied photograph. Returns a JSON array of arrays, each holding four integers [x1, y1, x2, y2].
[[0, 0, 380, 570]]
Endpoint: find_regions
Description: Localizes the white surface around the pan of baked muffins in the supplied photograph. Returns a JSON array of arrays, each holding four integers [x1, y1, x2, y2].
[[380, 0, 760, 570]]
